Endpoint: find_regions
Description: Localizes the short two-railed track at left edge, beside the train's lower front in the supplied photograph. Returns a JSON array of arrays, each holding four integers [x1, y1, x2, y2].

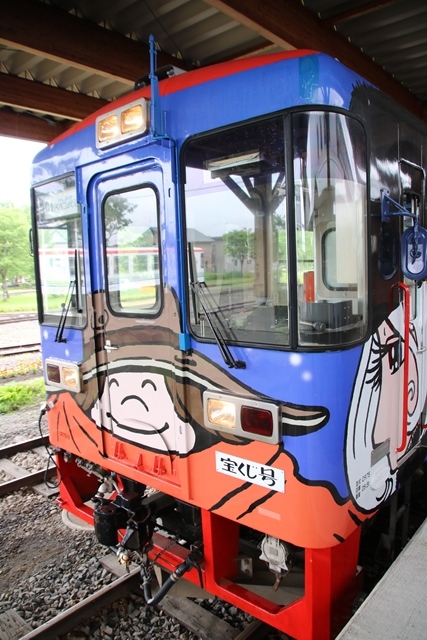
[[0, 436, 57, 497]]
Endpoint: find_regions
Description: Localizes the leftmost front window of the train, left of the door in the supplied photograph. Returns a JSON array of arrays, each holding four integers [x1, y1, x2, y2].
[[34, 175, 86, 327]]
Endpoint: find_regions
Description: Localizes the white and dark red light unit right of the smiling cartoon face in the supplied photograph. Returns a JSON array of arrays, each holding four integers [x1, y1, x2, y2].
[[203, 391, 280, 444]]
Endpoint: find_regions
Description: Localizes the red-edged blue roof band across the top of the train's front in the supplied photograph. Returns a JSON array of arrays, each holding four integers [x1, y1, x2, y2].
[[32, 49, 369, 184]]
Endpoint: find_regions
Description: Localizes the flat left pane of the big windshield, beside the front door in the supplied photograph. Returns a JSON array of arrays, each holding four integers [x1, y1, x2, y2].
[[184, 116, 289, 346]]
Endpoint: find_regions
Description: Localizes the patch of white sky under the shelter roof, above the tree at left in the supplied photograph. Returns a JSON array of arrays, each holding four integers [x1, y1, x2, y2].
[[0, 136, 45, 207]]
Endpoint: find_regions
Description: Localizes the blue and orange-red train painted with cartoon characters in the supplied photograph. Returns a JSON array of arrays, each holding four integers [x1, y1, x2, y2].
[[31, 38, 427, 640]]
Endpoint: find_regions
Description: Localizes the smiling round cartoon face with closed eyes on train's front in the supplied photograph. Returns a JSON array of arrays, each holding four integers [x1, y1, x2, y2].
[[91, 370, 196, 455]]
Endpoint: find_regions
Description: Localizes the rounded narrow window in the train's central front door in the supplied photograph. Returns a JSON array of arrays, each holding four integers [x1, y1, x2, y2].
[[103, 186, 161, 315]]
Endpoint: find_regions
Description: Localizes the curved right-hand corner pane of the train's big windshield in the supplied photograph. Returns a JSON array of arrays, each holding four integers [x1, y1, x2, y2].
[[293, 112, 367, 346]]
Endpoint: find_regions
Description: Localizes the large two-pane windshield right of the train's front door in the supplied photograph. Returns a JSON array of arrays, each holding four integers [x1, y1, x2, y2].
[[185, 112, 367, 347]]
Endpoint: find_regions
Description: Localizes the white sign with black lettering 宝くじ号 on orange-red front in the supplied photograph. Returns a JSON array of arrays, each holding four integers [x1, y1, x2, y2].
[[215, 451, 285, 493]]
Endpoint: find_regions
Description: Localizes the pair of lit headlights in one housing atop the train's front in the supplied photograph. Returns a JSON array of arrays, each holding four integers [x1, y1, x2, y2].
[[96, 98, 148, 149]]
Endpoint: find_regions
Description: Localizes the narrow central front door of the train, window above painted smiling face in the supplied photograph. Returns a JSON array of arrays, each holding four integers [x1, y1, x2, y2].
[[88, 164, 184, 465]]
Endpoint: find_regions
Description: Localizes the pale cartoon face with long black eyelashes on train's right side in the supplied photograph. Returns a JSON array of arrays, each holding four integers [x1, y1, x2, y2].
[[346, 305, 426, 511]]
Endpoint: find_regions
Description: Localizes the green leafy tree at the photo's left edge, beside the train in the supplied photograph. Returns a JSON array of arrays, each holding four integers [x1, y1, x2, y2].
[[0, 203, 34, 300]]
